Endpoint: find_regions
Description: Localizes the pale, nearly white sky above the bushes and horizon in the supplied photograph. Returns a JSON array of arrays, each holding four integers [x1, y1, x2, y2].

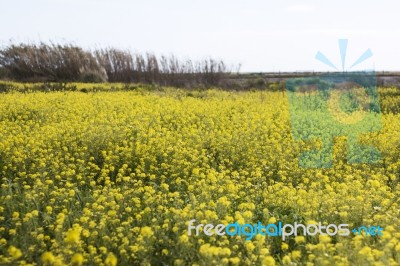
[[0, 0, 400, 72]]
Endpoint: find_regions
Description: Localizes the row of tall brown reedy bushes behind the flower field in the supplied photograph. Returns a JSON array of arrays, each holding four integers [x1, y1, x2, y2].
[[0, 43, 238, 87]]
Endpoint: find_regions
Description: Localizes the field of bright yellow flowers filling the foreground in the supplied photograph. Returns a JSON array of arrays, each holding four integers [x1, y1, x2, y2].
[[0, 88, 400, 265]]
